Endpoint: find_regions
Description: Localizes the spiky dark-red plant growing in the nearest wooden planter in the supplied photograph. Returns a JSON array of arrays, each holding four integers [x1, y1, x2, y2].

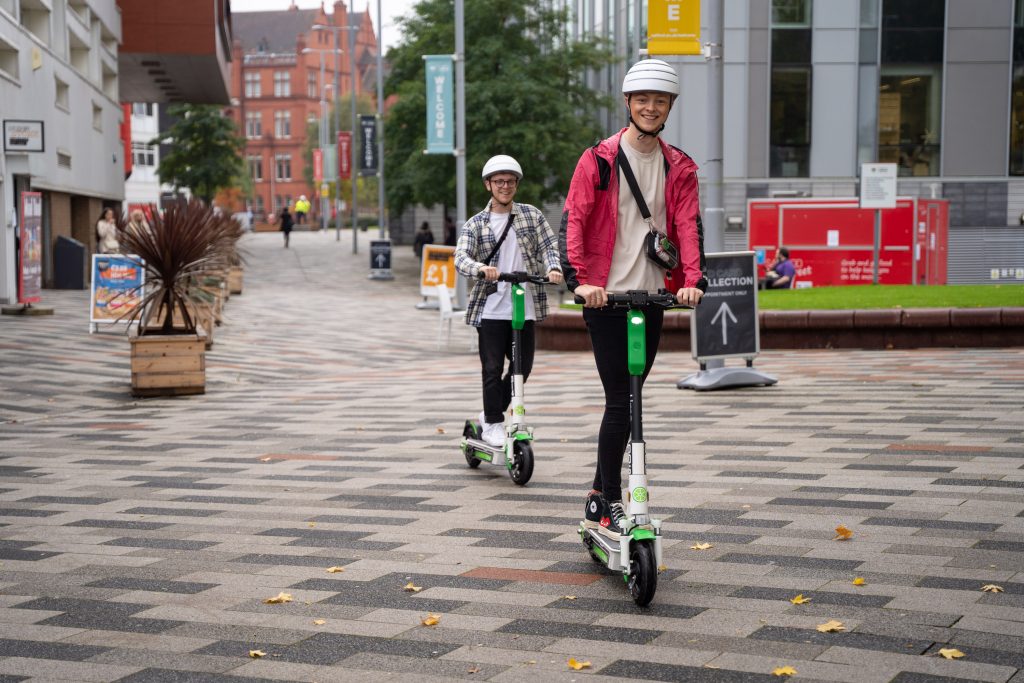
[[119, 200, 242, 335]]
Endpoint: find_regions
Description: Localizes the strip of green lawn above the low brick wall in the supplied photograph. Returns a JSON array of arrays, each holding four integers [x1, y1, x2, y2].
[[562, 285, 1024, 310]]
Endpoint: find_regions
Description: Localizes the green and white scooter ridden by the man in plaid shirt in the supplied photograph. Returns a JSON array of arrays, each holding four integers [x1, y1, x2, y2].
[[461, 271, 550, 486]]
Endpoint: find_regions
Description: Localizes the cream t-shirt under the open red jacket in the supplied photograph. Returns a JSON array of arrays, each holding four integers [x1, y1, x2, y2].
[[605, 141, 666, 292]]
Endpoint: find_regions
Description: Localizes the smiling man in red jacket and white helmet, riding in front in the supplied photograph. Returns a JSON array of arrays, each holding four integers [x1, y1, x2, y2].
[[559, 59, 708, 539]]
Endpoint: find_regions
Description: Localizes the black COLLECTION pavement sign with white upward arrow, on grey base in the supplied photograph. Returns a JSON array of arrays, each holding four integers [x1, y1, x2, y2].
[[676, 251, 778, 391]]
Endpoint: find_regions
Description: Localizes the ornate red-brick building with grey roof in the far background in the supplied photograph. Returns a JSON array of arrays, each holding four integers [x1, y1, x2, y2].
[[230, 2, 378, 220]]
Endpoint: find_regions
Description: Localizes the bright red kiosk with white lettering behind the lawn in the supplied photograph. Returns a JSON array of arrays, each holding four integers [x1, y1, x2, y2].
[[746, 197, 949, 288]]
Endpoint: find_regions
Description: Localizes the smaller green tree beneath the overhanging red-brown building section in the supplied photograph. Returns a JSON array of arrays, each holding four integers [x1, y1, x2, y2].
[[150, 104, 247, 204]]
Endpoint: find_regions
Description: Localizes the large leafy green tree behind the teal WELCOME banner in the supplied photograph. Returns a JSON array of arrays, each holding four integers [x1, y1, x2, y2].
[[384, 0, 611, 213]]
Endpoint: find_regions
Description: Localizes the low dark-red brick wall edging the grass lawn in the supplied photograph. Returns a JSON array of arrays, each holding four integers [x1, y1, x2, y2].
[[537, 307, 1024, 351]]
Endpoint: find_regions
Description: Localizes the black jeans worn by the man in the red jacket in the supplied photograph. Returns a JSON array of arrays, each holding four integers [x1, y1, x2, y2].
[[583, 307, 665, 503]]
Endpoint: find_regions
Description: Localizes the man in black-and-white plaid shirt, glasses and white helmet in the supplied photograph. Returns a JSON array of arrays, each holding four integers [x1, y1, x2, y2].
[[455, 155, 562, 446]]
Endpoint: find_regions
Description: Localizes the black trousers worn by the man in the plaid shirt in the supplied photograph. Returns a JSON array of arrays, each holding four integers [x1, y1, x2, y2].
[[476, 319, 535, 423]]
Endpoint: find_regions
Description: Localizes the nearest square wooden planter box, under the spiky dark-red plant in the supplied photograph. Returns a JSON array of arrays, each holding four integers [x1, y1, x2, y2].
[[129, 335, 206, 397]]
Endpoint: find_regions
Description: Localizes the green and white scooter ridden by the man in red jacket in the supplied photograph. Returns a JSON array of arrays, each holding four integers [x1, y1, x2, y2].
[[577, 290, 685, 607]]
